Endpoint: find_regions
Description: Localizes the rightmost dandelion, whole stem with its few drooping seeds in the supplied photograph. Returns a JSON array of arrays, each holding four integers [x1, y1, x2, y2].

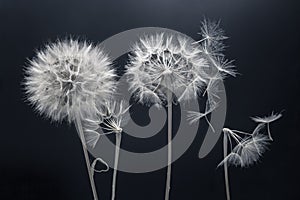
[[218, 110, 281, 200]]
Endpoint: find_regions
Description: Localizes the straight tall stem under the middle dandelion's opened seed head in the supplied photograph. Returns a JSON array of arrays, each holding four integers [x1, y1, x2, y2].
[[165, 93, 172, 200]]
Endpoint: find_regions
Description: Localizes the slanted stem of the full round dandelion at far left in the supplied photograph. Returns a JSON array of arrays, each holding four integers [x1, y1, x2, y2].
[[75, 115, 98, 200]]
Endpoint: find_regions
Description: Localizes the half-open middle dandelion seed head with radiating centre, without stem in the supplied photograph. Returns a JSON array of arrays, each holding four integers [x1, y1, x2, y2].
[[126, 33, 208, 105]]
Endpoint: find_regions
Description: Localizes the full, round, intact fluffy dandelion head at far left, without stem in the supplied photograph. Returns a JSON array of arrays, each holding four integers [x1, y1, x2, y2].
[[24, 39, 116, 122]]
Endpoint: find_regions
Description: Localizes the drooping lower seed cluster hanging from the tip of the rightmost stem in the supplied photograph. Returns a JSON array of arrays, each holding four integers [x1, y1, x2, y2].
[[218, 128, 270, 167]]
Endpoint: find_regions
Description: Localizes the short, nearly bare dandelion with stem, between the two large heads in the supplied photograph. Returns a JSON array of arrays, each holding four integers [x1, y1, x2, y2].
[[102, 100, 130, 200]]
